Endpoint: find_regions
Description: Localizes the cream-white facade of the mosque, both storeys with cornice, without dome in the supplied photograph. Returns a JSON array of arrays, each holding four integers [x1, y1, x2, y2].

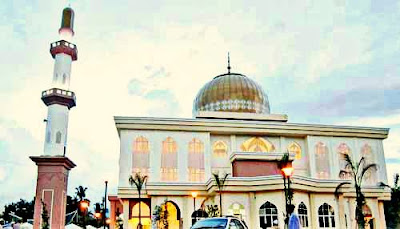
[[111, 117, 390, 228]]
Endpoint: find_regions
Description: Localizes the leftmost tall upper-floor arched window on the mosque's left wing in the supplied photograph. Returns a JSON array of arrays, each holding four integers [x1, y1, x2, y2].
[[132, 136, 150, 175]]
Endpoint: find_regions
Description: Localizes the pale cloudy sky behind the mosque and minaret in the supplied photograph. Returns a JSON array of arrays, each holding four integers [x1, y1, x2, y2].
[[0, 0, 400, 211]]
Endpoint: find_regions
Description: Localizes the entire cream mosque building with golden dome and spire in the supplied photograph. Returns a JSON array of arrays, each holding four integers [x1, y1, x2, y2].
[[109, 56, 390, 229]]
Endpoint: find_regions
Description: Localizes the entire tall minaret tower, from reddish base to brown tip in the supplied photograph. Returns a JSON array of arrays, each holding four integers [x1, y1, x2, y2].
[[30, 7, 78, 229]]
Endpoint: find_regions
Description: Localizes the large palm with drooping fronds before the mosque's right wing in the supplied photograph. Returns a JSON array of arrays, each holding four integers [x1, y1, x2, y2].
[[335, 154, 378, 229]]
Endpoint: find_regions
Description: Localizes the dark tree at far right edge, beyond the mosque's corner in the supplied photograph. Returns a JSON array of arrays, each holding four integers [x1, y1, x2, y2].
[[380, 173, 400, 228]]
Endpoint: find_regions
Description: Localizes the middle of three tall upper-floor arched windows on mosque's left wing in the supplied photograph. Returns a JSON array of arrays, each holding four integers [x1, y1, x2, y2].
[[161, 137, 178, 181]]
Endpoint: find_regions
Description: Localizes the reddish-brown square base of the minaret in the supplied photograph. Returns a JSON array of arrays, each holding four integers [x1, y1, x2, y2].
[[30, 156, 76, 229]]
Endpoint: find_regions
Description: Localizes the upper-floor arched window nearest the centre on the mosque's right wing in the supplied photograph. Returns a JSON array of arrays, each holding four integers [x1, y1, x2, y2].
[[315, 142, 330, 179]]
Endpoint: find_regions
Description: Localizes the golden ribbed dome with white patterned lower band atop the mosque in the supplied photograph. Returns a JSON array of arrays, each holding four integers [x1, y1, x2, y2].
[[193, 73, 270, 114]]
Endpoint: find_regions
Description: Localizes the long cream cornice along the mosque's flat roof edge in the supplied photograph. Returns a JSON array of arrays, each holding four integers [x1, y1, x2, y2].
[[114, 116, 389, 139]]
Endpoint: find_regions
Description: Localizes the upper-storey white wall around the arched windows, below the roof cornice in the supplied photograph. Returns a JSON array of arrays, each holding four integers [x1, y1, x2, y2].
[[119, 130, 387, 187]]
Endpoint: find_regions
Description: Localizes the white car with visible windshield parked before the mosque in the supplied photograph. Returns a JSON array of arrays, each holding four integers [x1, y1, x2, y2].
[[191, 217, 248, 229]]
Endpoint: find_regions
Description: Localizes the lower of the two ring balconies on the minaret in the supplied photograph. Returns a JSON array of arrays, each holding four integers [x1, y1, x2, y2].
[[42, 88, 76, 109]]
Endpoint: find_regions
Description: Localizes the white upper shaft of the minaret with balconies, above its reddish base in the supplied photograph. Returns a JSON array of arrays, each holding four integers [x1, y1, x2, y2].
[[42, 7, 78, 156]]
